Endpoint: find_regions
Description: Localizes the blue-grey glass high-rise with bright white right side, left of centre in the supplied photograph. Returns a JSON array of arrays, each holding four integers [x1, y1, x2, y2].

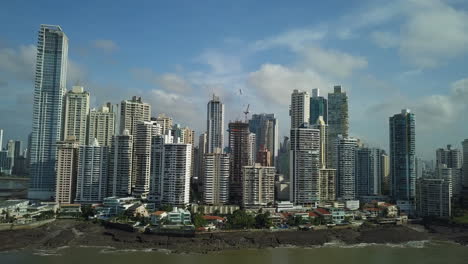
[[161, 143, 192, 206]]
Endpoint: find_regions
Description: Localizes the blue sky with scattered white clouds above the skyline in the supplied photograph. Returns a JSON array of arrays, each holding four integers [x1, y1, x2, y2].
[[0, 0, 468, 159]]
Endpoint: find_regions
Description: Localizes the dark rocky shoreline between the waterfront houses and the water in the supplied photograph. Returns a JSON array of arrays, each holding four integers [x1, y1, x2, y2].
[[0, 220, 468, 253]]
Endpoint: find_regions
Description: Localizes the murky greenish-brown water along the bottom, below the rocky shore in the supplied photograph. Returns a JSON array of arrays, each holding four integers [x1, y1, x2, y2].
[[0, 241, 468, 264]]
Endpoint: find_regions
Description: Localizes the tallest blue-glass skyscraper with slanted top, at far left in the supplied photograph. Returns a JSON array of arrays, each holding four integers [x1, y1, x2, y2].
[[28, 25, 68, 200]]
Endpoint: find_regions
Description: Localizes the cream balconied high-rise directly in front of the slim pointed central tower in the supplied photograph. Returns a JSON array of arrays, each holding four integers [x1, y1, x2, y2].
[[203, 149, 229, 205]]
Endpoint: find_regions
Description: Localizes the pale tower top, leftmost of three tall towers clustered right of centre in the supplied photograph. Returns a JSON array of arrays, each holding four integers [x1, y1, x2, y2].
[[289, 90, 310, 129]]
